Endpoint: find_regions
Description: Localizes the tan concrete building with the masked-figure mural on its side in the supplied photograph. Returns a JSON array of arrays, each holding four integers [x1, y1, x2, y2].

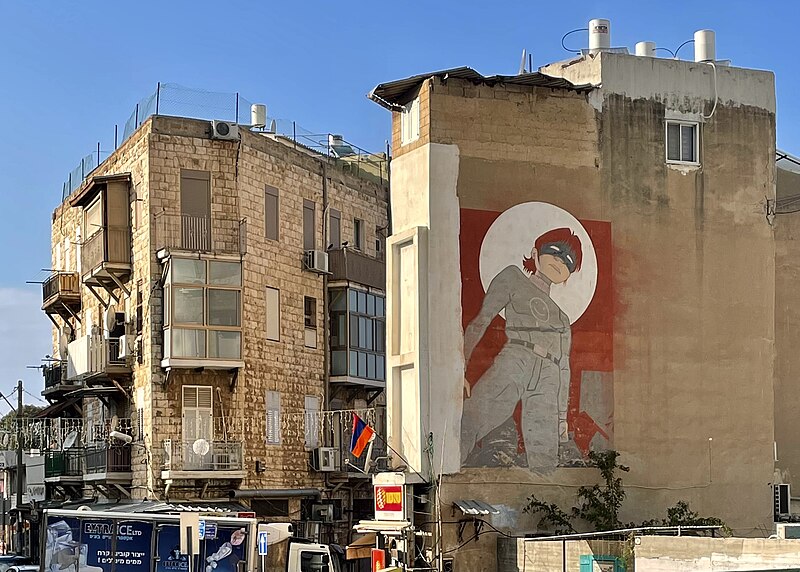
[[371, 22, 780, 571]]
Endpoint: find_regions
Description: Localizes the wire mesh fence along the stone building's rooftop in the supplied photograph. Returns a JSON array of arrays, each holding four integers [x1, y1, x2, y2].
[[61, 83, 389, 201]]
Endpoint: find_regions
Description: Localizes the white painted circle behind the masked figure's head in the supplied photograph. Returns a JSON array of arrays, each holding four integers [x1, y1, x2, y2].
[[480, 202, 597, 324]]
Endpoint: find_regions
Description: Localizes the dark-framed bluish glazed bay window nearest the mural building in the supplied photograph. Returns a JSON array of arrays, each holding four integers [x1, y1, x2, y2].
[[330, 288, 386, 381]]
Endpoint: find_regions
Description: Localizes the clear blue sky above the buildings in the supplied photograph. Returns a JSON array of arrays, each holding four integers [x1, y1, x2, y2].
[[0, 0, 800, 412]]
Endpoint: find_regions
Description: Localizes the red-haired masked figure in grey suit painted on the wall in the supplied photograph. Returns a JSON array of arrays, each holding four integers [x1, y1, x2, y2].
[[461, 228, 583, 469]]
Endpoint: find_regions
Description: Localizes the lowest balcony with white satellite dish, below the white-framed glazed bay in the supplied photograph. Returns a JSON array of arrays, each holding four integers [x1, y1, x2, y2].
[[161, 439, 247, 480]]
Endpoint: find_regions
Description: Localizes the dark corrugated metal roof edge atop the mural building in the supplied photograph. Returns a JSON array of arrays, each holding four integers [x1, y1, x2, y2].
[[368, 67, 594, 110]]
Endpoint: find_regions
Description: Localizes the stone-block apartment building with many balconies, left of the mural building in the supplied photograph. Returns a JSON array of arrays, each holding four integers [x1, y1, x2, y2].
[[37, 116, 388, 543]]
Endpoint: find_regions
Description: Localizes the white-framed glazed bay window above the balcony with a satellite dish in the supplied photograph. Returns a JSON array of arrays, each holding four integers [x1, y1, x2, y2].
[[164, 258, 242, 360]]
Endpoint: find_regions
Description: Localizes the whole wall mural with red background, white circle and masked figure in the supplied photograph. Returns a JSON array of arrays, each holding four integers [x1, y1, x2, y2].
[[460, 202, 614, 472]]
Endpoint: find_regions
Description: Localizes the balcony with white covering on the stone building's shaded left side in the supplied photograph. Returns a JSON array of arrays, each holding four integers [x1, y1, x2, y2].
[[67, 335, 131, 382]]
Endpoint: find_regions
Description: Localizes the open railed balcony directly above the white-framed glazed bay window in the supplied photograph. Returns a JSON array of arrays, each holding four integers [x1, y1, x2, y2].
[[153, 213, 247, 255]]
